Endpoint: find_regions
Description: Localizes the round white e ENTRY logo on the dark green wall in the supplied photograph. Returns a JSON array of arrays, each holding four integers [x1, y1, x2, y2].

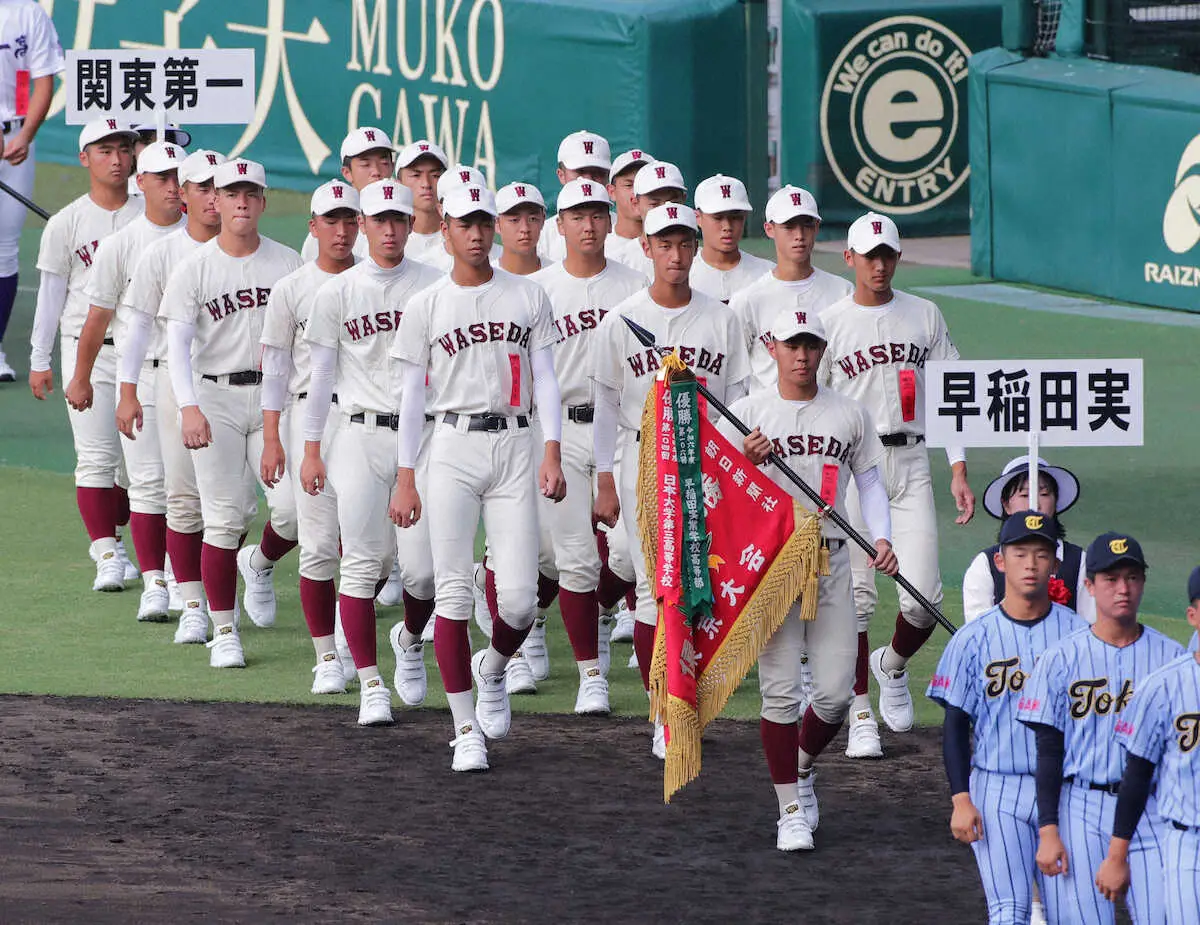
[[821, 16, 971, 215]]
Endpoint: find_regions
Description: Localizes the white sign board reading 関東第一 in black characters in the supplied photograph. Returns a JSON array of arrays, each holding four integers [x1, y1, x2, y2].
[[64, 48, 254, 125]]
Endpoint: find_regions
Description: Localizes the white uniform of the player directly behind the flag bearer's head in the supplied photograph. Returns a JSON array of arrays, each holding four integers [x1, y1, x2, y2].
[[724, 271, 854, 391]]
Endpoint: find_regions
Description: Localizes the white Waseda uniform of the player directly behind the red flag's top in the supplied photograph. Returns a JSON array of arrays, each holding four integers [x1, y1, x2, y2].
[[592, 289, 750, 625]]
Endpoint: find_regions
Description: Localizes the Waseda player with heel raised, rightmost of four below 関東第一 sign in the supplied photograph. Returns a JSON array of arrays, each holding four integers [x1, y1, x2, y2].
[[162, 158, 301, 668]]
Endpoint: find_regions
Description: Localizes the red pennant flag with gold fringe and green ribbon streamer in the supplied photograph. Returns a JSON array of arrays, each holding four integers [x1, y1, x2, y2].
[[637, 354, 828, 803]]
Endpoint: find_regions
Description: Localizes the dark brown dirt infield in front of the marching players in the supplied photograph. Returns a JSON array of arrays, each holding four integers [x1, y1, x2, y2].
[[0, 697, 985, 924]]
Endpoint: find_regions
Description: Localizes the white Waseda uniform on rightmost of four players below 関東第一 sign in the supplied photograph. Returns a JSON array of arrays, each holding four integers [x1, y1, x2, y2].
[[162, 238, 301, 549]]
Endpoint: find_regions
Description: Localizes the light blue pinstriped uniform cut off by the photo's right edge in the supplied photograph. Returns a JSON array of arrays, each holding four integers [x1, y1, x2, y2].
[[1117, 653, 1200, 925]]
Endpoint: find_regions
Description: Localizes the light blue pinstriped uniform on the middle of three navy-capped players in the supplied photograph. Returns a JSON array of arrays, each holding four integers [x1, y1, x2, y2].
[[1018, 626, 1183, 925]]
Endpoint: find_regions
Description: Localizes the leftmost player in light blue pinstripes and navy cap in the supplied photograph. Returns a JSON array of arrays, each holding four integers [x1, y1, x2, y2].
[[925, 510, 1087, 925]]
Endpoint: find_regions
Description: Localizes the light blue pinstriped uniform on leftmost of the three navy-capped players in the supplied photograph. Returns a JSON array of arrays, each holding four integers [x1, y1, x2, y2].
[[925, 603, 1087, 925]]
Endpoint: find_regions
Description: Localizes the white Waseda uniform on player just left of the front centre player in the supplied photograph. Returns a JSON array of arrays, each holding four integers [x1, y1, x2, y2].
[[304, 257, 442, 600]]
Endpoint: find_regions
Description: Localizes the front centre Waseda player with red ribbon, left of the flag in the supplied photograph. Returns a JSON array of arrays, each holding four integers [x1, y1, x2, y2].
[[390, 184, 566, 771]]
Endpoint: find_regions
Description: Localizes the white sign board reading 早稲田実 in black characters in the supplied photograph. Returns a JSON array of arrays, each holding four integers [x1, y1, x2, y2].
[[925, 360, 1144, 446]]
